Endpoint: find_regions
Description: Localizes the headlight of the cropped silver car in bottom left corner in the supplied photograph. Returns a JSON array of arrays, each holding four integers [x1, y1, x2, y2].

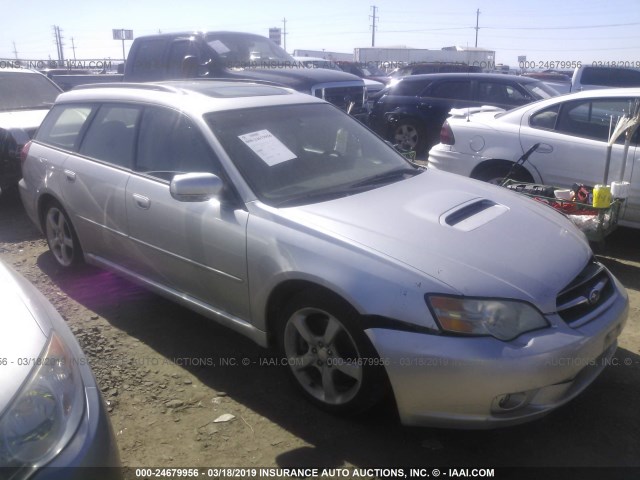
[[0, 332, 84, 468]]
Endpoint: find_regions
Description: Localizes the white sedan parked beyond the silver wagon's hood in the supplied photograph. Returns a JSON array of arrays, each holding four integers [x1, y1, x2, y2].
[[429, 88, 640, 228]]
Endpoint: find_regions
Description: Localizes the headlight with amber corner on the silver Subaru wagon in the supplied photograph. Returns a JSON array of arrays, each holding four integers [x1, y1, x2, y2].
[[426, 295, 549, 341]]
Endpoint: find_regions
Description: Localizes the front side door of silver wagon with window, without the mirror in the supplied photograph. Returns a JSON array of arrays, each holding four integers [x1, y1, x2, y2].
[[126, 107, 249, 318]]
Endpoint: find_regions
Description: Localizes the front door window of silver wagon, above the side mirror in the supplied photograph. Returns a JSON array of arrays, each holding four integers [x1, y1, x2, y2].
[[135, 107, 220, 180]]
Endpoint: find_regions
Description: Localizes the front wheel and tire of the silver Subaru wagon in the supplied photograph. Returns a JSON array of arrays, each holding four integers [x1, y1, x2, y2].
[[278, 290, 388, 414]]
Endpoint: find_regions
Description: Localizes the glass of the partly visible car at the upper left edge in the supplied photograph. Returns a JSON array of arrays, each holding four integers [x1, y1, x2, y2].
[[0, 72, 60, 111]]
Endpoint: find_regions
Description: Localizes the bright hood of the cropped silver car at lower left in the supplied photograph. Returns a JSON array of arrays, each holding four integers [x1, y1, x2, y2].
[[0, 263, 47, 415]]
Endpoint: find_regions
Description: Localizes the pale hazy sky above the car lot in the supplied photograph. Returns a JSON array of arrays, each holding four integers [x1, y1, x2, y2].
[[0, 0, 640, 69]]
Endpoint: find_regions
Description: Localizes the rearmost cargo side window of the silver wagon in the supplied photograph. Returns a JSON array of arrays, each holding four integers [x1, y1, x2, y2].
[[35, 105, 94, 150]]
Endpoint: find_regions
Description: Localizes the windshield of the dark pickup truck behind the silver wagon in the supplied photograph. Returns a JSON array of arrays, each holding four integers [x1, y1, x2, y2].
[[207, 32, 295, 68]]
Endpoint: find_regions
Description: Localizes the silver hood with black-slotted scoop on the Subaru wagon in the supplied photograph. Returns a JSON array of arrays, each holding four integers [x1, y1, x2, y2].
[[283, 171, 592, 312]]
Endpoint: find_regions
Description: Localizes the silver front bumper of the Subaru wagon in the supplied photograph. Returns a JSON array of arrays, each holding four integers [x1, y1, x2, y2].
[[367, 282, 629, 429]]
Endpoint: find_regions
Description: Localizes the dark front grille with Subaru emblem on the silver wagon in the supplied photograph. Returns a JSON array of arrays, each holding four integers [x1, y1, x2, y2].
[[556, 259, 614, 325]]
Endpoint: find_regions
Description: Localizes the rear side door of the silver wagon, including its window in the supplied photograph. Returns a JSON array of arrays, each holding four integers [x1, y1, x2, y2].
[[61, 104, 140, 262]]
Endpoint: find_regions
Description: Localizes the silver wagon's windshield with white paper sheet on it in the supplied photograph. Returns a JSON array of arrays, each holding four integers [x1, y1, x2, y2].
[[205, 104, 423, 206]]
